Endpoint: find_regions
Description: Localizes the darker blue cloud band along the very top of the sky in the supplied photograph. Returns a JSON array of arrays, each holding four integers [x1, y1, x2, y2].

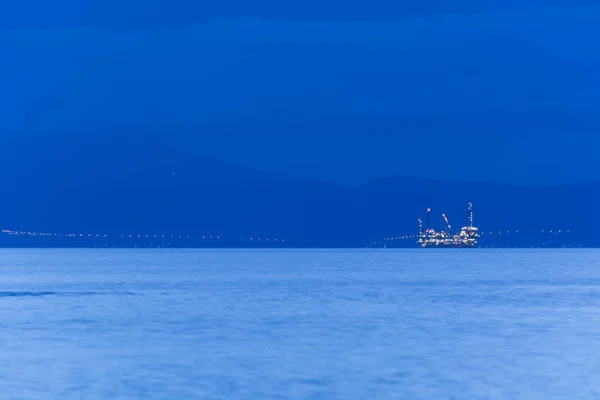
[[0, 0, 597, 28]]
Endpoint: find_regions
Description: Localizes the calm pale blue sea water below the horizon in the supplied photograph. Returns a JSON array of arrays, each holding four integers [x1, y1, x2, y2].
[[0, 250, 600, 400]]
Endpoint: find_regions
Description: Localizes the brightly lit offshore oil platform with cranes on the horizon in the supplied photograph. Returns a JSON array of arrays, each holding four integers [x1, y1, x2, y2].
[[419, 202, 479, 248]]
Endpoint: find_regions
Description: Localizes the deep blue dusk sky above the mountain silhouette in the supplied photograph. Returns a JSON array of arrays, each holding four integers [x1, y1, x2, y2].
[[0, 0, 600, 185]]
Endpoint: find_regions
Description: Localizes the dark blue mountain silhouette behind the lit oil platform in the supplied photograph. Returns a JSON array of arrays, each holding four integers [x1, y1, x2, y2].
[[0, 137, 600, 247]]
